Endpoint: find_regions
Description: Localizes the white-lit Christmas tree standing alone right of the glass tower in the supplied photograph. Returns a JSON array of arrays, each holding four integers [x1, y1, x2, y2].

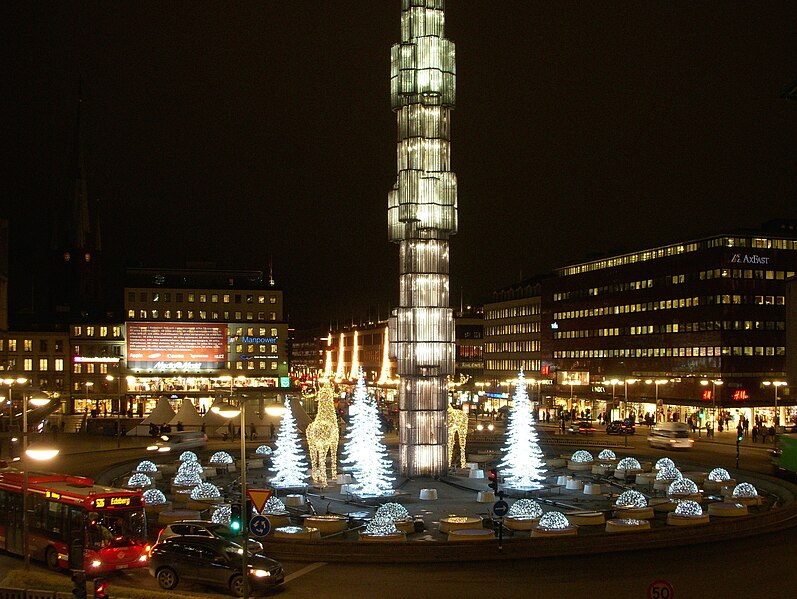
[[498, 370, 545, 489]]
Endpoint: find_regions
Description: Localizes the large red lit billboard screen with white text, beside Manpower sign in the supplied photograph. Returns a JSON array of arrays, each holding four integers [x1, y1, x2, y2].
[[127, 322, 227, 372]]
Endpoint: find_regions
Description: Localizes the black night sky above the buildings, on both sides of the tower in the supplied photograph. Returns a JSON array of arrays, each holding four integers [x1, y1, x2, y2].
[[6, 0, 797, 326]]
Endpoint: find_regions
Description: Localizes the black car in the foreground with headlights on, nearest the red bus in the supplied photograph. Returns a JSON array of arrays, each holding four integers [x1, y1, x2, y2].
[[149, 536, 285, 597]]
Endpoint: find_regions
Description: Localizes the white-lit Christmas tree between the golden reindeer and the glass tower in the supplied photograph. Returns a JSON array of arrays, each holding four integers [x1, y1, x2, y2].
[[341, 369, 393, 496]]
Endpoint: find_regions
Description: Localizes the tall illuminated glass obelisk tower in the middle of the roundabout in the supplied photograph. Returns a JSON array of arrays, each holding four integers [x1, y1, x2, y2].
[[388, 0, 457, 476]]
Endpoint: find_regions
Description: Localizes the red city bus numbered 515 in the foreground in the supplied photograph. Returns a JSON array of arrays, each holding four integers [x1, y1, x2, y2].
[[0, 469, 149, 574]]
